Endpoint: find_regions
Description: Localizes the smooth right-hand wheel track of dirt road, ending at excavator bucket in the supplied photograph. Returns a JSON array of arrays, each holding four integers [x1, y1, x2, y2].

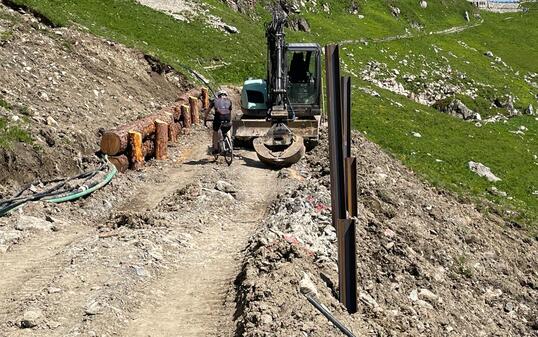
[[124, 152, 278, 337]]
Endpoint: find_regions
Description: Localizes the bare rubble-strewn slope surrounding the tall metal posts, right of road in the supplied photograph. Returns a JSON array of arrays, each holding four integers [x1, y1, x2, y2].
[[237, 130, 538, 336]]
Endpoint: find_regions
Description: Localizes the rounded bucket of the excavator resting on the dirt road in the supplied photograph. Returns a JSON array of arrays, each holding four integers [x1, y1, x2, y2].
[[253, 135, 305, 167]]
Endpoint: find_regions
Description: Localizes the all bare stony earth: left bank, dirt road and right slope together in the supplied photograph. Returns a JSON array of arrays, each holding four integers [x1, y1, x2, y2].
[[0, 6, 538, 337]]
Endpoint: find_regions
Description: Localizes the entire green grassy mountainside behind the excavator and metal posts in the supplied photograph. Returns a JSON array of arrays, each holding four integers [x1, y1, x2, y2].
[[7, 0, 538, 225]]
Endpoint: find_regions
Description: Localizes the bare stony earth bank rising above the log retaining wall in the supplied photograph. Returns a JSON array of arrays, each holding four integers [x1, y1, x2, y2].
[[0, 5, 186, 189]]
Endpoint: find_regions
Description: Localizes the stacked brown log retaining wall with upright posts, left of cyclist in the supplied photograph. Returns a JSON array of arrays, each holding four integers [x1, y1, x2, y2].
[[101, 88, 209, 172]]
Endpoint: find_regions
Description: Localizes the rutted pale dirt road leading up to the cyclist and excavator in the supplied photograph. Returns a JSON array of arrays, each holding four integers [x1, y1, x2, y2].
[[0, 131, 279, 336]]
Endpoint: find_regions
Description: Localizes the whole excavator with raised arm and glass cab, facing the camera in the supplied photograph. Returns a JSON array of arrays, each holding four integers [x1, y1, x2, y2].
[[233, 11, 322, 167]]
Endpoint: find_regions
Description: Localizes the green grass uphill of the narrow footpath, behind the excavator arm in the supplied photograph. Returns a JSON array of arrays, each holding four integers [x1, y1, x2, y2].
[[7, 0, 478, 84]]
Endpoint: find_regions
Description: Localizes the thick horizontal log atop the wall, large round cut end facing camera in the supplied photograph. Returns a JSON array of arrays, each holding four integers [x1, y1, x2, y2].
[[101, 111, 173, 156]]
